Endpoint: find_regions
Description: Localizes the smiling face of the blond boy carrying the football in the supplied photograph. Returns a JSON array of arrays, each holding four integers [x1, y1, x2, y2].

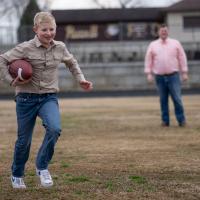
[[33, 22, 56, 48]]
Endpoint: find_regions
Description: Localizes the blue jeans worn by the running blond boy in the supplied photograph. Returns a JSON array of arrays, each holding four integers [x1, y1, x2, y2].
[[12, 93, 61, 177]]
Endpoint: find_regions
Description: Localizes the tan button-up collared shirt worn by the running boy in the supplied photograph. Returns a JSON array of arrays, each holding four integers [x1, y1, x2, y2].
[[0, 36, 85, 94]]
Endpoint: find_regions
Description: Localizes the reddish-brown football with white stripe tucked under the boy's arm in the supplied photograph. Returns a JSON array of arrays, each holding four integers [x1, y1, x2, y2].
[[8, 60, 33, 81]]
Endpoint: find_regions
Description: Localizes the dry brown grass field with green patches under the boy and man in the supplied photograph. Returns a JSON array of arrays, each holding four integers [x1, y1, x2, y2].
[[0, 95, 200, 200]]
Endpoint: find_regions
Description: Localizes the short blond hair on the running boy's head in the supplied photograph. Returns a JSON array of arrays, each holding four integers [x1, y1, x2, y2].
[[33, 12, 56, 26]]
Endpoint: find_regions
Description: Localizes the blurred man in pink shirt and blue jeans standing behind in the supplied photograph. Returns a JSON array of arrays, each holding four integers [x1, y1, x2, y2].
[[144, 25, 188, 126]]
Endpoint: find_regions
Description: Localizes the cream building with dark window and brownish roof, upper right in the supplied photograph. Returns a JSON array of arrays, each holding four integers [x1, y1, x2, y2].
[[165, 0, 200, 43]]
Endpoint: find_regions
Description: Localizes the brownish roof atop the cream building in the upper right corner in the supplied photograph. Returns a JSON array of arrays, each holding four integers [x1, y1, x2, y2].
[[165, 0, 200, 12]]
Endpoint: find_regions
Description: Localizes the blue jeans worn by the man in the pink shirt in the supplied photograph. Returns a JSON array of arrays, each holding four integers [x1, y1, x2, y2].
[[155, 72, 185, 125]]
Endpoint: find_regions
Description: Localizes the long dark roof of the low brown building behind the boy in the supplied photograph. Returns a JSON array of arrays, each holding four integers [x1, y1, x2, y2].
[[52, 8, 164, 25]]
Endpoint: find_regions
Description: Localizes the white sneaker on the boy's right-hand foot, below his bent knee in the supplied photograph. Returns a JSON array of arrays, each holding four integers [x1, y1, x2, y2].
[[36, 169, 53, 187]]
